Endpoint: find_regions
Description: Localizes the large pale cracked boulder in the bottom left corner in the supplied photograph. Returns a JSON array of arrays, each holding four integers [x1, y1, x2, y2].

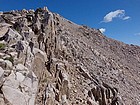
[[2, 69, 38, 105]]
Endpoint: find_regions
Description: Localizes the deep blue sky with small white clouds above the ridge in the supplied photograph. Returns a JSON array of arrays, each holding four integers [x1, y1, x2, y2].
[[0, 0, 140, 45]]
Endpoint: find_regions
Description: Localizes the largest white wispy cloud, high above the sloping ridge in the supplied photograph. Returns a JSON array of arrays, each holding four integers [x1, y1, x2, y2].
[[102, 10, 130, 23]]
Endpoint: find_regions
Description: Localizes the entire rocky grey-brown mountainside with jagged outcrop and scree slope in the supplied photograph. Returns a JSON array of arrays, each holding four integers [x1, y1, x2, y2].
[[0, 7, 140, 105]]
